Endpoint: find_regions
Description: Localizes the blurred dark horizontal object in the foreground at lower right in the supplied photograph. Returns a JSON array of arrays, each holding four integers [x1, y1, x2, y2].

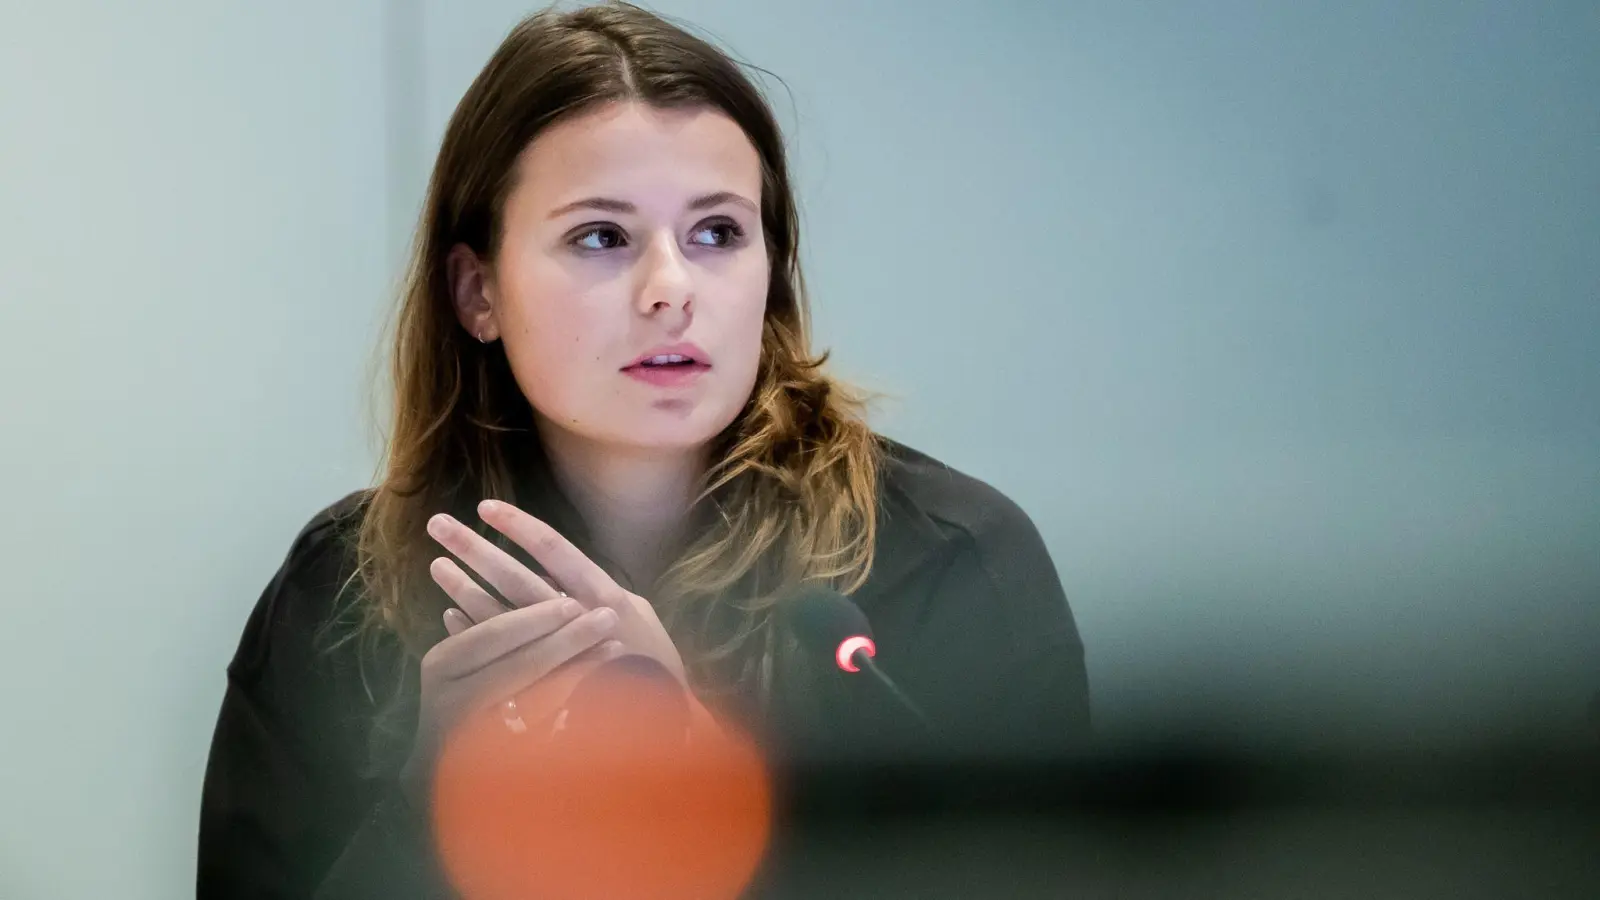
[[758, 746, 1600, 900]]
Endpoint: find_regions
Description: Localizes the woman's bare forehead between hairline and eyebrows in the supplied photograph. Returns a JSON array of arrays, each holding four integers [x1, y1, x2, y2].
[[517, 102, 762, 207]]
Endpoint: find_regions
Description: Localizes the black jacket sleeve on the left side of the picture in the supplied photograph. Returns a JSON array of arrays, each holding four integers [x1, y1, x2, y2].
[[197, 509, 450, 900]]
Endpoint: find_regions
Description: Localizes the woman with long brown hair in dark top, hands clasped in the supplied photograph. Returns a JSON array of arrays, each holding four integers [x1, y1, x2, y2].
[[200, 3, 1088, 898]]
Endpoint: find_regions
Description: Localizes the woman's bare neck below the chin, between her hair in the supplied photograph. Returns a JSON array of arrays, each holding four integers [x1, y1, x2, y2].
[[539, 428, 709, 591]]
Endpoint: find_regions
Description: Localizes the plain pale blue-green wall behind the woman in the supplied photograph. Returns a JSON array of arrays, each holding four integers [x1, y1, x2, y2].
[[0, 0, 1600, 898]]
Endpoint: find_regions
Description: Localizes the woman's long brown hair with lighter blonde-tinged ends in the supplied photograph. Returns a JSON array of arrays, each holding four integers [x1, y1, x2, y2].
[[352, 3, 882, 689]]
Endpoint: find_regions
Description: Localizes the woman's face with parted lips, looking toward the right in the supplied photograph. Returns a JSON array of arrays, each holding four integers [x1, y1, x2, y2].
[[453, 102, 770, 450]]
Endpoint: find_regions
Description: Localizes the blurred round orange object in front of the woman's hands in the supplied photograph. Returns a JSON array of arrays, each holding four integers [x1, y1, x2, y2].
[[434, 657, 771, 900]]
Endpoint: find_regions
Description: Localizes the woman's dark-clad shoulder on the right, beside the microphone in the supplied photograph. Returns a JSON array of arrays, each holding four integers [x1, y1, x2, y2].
[[861, 442, 1088, 754]]
